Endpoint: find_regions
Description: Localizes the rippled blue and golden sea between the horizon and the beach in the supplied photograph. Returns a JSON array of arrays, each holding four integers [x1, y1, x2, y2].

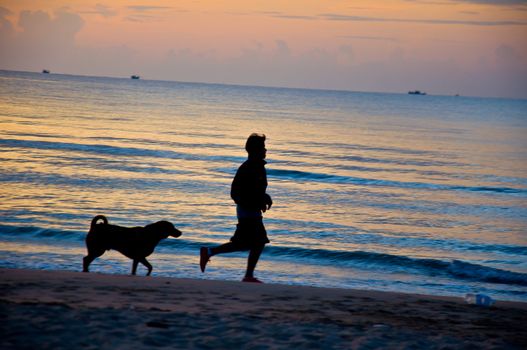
[[0, 71, 527, 302]]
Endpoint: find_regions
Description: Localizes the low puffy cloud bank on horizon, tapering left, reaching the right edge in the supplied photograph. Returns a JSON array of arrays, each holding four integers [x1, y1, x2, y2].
[[133, 39, 527, 98]]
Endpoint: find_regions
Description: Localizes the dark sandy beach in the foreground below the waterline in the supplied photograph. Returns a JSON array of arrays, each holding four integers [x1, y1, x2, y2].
[[0, 269, 527, 349]]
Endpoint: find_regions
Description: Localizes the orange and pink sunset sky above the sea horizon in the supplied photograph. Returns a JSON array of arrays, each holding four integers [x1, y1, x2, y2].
[[0, 0, 527, 98]]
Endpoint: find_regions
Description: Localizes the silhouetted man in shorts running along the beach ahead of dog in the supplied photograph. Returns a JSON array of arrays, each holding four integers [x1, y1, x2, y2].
[[199, 134, 273, 283]]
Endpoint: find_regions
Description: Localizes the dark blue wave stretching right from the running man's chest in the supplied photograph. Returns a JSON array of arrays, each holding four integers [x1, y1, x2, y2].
[[267, 169, 527, 194]]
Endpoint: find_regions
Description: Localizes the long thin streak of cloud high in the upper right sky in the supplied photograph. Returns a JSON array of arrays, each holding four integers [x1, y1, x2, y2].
[[320, 13, 527, 26]]
